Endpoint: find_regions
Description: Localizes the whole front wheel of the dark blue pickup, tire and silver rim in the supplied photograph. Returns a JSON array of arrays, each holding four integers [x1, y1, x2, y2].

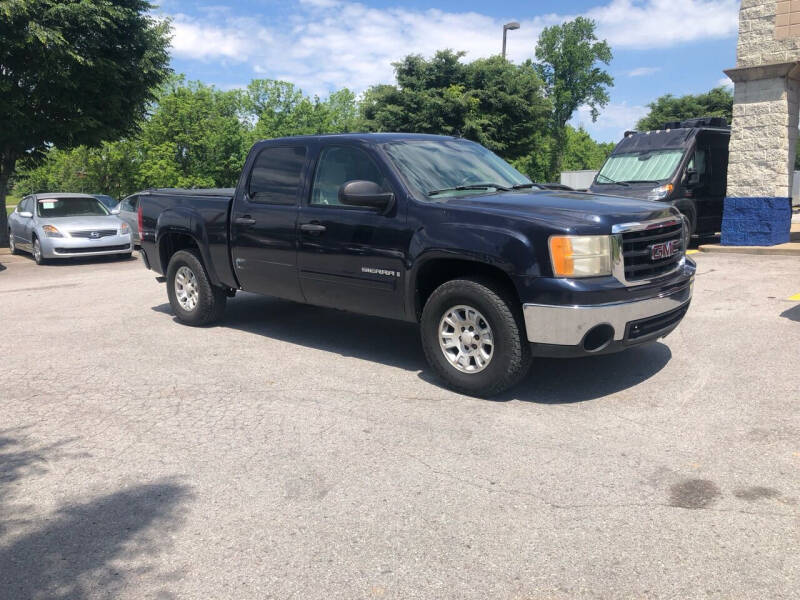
[[420, 279, 531, 397]]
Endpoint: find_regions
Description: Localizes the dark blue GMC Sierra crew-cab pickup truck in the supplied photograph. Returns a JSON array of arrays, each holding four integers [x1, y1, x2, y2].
[[138, 134, 695, 396]]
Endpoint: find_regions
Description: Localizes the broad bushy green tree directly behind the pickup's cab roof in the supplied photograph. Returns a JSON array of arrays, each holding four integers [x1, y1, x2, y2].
[[361, 50, 550, 160]]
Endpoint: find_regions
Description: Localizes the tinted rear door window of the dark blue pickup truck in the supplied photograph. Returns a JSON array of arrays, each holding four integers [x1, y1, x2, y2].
[[247, 146, 306, 205]]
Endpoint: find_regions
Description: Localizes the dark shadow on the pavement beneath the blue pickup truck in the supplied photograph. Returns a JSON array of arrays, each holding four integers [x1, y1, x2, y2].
[[153, 294, 672, 404]]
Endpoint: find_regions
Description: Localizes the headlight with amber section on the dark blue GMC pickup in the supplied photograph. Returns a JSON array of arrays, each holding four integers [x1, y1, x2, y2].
[[550, 235, 611, 277]]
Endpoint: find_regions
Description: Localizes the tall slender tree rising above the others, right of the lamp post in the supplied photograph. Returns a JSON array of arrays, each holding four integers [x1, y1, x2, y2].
[[535, 17, 614, 178]]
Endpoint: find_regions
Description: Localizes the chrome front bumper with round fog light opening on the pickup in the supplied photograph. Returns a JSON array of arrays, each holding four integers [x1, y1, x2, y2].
[[522, 277, 694, 355]]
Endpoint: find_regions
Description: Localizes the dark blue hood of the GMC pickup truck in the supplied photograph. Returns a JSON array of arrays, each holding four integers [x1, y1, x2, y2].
[[441, 190, 676, 235]]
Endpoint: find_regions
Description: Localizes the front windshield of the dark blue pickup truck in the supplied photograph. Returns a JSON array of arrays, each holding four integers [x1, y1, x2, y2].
[[383, 140, 531, 198]]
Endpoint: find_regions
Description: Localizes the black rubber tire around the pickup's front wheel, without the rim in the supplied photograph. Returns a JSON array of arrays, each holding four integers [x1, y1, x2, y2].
[[420, 278, 532, 398]]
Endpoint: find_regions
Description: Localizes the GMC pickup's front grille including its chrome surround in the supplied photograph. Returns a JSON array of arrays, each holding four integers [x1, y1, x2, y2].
[[614, 217, 687, 285]]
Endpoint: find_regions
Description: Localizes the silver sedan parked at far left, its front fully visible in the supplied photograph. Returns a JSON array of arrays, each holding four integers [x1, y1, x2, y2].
[[8, 194, 133, 265]]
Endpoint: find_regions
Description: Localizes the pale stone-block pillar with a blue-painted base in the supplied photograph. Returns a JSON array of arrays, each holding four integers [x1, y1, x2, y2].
[[722, 0, 800, 245]]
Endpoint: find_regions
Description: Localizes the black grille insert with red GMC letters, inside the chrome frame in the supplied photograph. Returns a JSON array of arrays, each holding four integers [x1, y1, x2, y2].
[[622, 219, 686, 281]]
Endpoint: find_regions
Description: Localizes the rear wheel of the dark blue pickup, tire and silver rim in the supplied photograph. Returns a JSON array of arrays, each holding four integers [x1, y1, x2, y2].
[[167, 250, 227, 326]]
